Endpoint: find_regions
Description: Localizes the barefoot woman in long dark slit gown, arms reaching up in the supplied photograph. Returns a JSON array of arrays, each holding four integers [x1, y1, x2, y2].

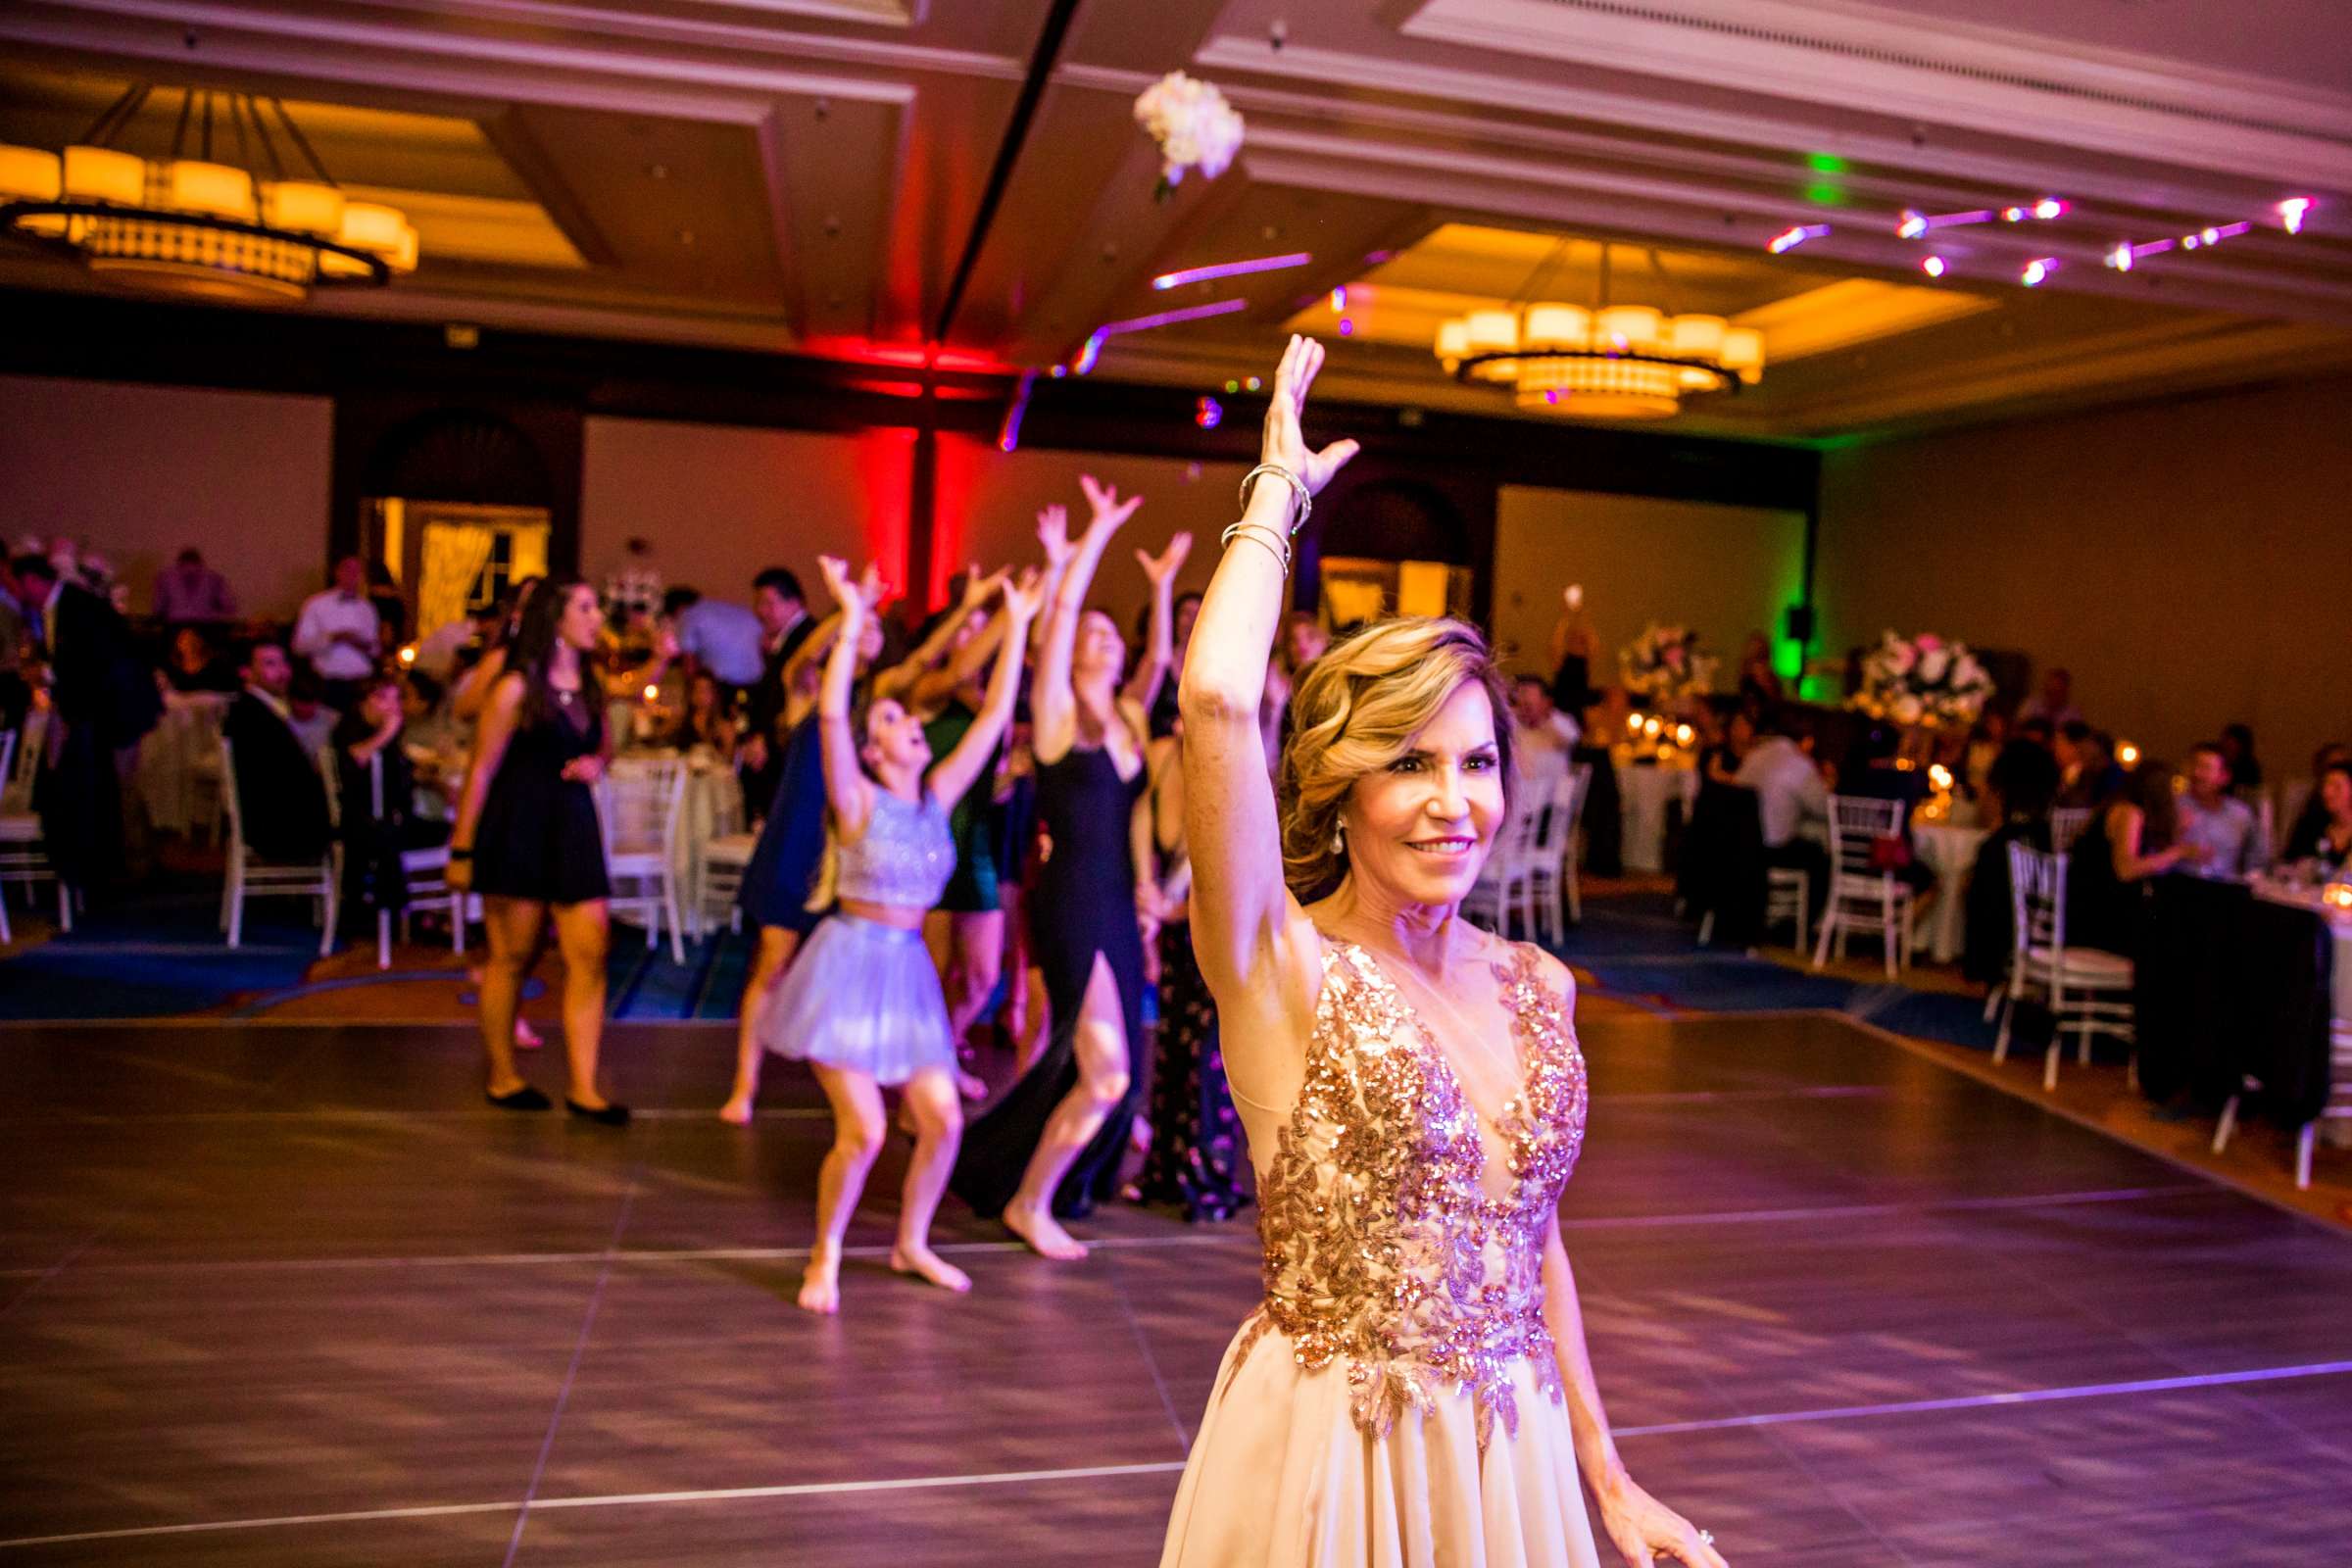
[[953, 475, 1193, 1260]]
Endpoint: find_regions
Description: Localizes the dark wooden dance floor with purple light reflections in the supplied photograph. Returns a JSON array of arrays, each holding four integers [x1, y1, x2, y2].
[[0, 1015, 2352, 1568]]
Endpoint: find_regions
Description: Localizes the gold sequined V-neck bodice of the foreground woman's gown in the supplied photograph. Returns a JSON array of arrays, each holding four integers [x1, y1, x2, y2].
[[1233, 943, 1586, 1448]]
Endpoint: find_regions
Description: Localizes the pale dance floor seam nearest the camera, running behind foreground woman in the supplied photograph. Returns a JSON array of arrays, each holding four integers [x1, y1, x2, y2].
[[0, 1363, 2352, 1561]]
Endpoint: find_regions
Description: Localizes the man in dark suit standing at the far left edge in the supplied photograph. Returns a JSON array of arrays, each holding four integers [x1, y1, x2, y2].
[[14, 555, 163, 898]]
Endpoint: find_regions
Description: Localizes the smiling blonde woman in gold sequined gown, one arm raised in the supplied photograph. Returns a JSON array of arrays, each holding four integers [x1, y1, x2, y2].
[[1162, 338, 1724, 1568]]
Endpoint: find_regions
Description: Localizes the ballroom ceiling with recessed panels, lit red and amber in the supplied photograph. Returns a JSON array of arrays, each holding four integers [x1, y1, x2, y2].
[[0, 0, 2352, 440]]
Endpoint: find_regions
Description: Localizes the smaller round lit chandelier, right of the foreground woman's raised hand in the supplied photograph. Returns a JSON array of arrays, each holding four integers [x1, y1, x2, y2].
[[1437, 242, 1764, 418]]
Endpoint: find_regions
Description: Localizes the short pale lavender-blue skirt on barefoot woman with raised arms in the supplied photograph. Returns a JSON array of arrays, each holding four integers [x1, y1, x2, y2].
[[760, 909, 955, 1089]]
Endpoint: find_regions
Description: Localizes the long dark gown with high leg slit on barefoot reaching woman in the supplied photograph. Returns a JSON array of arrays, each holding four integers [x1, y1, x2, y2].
[[951, 748, 1146, 1220]]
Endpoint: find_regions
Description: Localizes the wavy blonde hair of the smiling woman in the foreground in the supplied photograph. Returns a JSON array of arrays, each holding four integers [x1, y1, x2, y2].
[[1277, 615, 1517, 903]]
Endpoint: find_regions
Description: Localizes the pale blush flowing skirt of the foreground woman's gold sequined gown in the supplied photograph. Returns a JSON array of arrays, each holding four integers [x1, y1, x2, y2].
[[1159, 1328, 1599, 1568]]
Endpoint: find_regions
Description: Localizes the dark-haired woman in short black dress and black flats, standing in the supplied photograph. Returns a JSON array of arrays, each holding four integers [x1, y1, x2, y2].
[[449, 578, 628, 1126]]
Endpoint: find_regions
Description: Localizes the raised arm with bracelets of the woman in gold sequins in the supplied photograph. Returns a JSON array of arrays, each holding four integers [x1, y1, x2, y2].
[[1178, 336, 1357, 1102]]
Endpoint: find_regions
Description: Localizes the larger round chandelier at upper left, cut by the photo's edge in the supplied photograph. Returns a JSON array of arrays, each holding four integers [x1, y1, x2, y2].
[[0, 82, 416, 301]]
